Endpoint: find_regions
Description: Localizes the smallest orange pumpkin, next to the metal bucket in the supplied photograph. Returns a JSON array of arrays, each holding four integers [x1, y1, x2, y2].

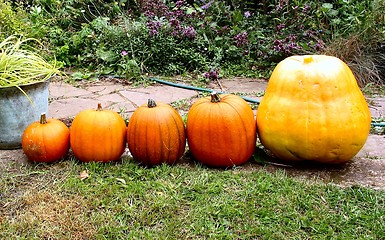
[[21, 113, 70, 162]]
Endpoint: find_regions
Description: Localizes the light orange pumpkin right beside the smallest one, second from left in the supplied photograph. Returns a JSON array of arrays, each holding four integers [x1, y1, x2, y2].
[[70, 103, 126, 162]]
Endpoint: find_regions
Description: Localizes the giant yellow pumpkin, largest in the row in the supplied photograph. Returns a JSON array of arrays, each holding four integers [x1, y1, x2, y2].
[[257, 55, 371, 164]]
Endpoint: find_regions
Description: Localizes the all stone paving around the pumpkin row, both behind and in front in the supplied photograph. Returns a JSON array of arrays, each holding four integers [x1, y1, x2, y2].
[[0, 78, 385, 189]]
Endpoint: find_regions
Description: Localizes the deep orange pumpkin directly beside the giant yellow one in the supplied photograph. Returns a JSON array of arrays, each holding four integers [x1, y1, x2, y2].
[[186, 92, 256, 167]]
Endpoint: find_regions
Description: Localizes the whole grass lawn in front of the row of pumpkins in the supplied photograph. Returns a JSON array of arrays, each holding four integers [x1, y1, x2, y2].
[[0, 155, 385, 239]]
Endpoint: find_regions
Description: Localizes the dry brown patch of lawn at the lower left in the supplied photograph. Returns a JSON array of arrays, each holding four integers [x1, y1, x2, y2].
[[5, 190, 97, 239]]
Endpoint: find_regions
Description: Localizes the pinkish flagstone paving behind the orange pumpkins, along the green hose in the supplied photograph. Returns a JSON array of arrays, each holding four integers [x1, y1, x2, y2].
[[48, 79, 266, 119]]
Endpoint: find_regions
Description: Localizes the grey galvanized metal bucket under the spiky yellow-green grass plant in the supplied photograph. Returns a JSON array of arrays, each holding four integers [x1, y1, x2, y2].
[[0, 81, 49, 149]]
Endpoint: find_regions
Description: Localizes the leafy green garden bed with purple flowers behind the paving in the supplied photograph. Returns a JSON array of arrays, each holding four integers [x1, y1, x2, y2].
[[0, 0, 385, 81]]
